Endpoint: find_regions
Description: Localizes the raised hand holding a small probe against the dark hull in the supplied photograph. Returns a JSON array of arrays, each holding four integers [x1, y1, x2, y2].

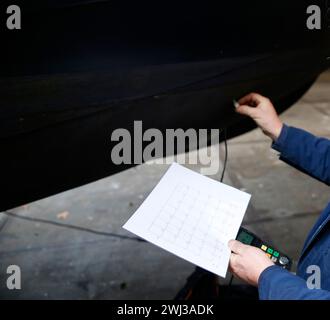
[[236, 93, 283, 141]]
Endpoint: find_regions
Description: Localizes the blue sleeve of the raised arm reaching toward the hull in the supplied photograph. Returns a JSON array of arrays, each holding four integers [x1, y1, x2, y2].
[[272, 125, 330, 185]]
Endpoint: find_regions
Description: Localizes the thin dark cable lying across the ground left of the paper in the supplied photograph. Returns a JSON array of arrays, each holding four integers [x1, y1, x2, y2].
[[3, 211, 147, 242]]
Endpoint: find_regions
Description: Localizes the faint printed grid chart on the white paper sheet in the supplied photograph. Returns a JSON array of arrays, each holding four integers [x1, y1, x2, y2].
[[148, 183, 240, 268]]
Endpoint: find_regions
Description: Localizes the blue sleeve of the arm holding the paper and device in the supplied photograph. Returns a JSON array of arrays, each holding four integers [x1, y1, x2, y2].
[[258, 266, 330, 300]]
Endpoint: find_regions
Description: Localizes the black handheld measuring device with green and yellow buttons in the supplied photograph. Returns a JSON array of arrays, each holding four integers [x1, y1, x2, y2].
[[236, 227, 292, 270]]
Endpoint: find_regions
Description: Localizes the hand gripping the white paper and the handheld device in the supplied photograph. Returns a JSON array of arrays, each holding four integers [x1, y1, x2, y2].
[[228, 240, 274, 286]]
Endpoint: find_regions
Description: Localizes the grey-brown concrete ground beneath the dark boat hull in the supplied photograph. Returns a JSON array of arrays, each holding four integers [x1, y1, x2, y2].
[[0, 73, 330, 299]]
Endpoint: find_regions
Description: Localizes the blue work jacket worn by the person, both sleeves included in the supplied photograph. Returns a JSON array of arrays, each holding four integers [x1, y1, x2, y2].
[[258, 125, 330, 300]]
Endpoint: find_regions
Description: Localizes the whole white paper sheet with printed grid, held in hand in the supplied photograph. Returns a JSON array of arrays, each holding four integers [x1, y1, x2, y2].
[[123, 163, 251, 277]]
